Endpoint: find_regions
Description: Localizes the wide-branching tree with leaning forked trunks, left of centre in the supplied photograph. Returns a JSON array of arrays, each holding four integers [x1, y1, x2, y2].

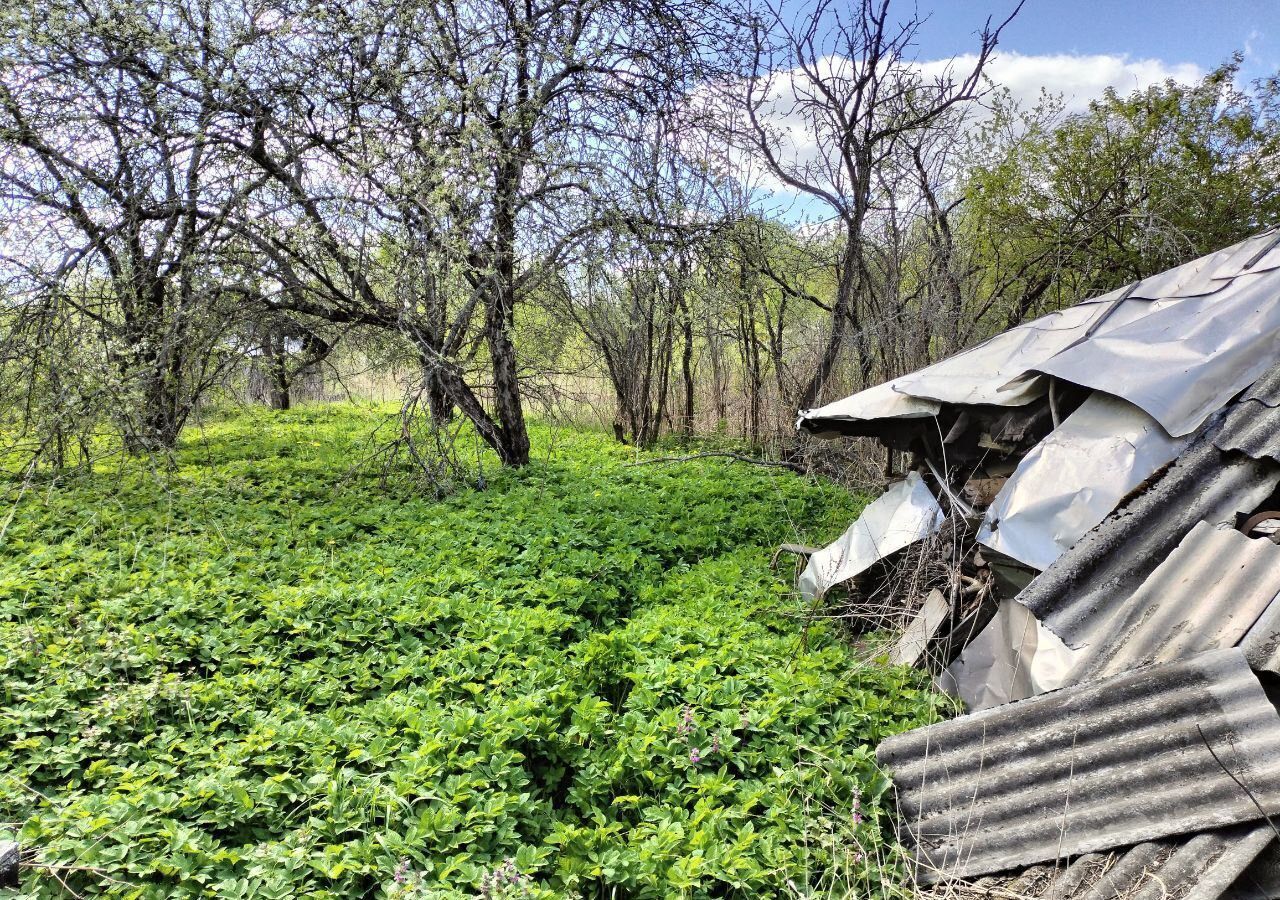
[[203, 0, 737, 465]]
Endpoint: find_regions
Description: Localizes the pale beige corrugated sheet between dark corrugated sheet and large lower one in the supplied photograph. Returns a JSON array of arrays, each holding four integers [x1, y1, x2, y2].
[[1065, 522, 1280, 685]]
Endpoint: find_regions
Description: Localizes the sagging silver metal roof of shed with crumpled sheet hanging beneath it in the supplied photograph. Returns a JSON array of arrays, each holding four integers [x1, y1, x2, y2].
[[799, 229, 1280, 578]]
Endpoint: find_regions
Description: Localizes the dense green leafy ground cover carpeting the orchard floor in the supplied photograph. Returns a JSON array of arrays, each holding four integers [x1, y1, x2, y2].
[[0, 406, 934, 897]]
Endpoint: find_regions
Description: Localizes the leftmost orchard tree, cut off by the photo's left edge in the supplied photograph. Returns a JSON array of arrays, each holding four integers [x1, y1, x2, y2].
[[0, 0, 257, 452]]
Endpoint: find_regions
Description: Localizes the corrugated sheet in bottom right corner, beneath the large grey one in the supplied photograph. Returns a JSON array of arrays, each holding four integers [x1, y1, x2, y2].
[[966, 822, 1275, 900]]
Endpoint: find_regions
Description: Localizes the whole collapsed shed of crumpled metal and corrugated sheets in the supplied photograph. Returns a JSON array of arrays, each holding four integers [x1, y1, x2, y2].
[[799, 230, 1280, 899]]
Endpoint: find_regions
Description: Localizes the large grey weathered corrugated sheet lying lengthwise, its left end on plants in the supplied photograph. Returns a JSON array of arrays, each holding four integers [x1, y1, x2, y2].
[[877, 649, 1280, 883]]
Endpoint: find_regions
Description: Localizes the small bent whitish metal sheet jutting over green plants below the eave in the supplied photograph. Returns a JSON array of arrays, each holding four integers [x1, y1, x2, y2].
[[796, 472, 943, 599]]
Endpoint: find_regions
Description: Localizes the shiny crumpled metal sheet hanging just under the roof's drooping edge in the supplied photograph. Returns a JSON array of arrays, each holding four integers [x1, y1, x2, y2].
[[978, 393, 1188, 570]]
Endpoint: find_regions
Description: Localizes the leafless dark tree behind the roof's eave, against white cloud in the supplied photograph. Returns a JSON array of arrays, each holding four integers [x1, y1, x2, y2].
[[741, 0, 1016, 406]]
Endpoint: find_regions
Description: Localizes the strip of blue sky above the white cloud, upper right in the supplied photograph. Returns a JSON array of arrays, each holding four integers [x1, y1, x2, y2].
[[916, 0, 1280, 78]]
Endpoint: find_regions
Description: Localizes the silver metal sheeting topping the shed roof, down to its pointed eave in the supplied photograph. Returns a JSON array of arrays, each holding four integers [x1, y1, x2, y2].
[[797, 224, 1280, 437]]
